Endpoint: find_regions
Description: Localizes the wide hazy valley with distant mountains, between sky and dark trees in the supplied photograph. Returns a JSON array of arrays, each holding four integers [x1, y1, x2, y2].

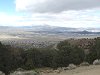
[[0, 25, 100, 48]]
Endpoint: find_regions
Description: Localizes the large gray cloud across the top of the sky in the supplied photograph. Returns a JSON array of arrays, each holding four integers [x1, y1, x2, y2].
[[19, 0, 100, 13]]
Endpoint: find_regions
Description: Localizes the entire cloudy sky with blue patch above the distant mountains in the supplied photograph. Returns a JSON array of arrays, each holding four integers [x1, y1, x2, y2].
[[0, 0, 100, 28]]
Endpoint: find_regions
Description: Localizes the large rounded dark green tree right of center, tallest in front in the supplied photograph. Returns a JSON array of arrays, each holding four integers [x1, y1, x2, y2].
[[57, 41, 84, 66]]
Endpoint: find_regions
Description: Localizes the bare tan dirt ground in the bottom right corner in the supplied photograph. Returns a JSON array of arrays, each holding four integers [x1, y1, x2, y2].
[[42, 65, 100, 75]]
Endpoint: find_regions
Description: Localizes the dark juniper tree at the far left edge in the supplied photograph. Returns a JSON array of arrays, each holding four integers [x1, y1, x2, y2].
[[0, 43, 17, 75]]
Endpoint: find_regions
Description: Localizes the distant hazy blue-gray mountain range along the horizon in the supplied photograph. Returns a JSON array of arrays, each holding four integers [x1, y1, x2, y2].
[[0, 25, 100, 36]]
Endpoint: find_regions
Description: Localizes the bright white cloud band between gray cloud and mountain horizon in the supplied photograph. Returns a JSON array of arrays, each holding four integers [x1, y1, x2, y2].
[[0, 9, 100, 28]]
